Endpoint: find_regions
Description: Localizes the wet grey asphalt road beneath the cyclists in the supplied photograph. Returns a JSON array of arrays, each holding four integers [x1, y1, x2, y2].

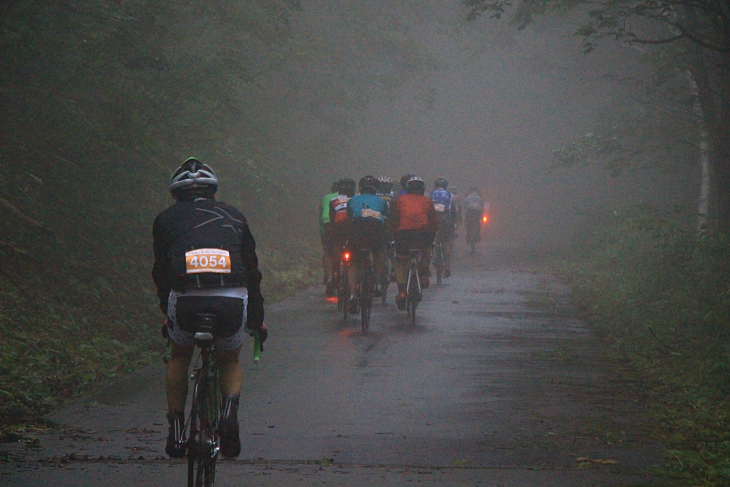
[[0, 242, 660, 486]]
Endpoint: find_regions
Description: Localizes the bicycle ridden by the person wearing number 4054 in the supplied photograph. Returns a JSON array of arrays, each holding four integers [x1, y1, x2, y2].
[[185, 313, 262, 487]]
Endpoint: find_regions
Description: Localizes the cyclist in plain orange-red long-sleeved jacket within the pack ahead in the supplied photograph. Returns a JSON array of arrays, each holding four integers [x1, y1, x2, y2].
[[390, 176, 438, 310]]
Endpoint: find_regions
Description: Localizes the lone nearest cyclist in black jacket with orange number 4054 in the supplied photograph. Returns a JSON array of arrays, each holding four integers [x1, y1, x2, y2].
[[152, 157, 267, 458]]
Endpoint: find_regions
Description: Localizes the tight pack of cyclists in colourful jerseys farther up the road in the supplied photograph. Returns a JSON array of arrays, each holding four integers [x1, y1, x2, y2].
[[319, 174, 462, 310]]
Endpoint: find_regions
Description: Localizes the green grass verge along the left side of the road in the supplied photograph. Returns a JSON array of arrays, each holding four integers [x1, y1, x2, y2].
[[0, 249, 318, 441]]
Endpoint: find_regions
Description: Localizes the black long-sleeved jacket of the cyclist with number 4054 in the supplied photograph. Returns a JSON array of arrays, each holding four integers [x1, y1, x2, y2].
[[152, 198, 264, 329]]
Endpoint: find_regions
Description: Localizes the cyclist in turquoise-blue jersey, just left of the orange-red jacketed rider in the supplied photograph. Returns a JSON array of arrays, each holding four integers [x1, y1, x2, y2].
[[347, 176, 389, 307]]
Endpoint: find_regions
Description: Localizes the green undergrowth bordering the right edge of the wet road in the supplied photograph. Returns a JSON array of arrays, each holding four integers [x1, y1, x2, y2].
[[555, 212, 730, 487]]
